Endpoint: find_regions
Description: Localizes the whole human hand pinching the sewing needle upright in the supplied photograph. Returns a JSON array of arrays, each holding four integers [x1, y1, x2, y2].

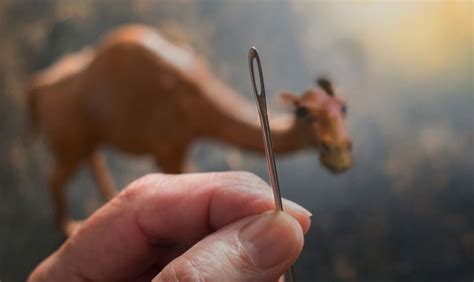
[[29, 172, 311, 281]]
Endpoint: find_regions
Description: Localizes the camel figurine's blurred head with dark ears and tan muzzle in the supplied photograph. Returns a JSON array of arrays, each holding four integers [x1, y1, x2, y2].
[[281, 78, 353, 173]]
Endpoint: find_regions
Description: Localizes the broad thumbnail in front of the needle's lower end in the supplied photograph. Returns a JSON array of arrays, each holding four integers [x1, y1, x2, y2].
[[239, 212, 303, 269]]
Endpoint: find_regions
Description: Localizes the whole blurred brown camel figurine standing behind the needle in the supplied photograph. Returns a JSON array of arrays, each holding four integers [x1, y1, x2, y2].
[[27, 25, 352, 234]]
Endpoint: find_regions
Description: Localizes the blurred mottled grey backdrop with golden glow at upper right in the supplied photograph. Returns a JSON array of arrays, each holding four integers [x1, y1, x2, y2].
[[0, 0, 474, 281]]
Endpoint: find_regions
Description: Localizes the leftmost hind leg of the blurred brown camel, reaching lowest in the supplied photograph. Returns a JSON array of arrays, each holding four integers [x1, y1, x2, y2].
[[49, 159, 78, 235]]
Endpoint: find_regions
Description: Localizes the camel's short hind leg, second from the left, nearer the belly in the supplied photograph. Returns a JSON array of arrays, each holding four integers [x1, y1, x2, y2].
[[89, 151, 117, 201]]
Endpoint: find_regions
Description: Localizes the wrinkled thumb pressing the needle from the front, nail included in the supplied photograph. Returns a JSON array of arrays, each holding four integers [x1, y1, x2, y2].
[[153, 212, 304, 281]]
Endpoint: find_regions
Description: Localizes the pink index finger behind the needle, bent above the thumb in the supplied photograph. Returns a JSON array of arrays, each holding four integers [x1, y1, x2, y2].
[[38, 172, 310, 280]]
